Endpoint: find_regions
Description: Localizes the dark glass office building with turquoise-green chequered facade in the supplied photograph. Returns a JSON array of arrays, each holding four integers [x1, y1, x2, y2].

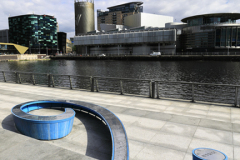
[[8, 14, 57, 54]]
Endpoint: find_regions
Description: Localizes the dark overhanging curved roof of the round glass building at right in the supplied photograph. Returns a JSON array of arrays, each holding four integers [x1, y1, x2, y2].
[[181, 13, 240, 23]]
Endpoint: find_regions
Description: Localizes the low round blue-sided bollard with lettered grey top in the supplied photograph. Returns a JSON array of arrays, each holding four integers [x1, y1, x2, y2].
[[192, 148, 228, 160]]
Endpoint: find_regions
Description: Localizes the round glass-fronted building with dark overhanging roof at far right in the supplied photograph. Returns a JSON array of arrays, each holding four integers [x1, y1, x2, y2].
[[180, 13, 240, 52]]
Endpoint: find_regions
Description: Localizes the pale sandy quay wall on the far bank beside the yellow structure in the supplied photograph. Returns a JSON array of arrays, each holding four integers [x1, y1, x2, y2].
[[0, 54, 47, 61]]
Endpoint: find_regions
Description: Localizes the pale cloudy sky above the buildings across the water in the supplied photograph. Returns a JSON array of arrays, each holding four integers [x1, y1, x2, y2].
[[0, 0, 240, 38]]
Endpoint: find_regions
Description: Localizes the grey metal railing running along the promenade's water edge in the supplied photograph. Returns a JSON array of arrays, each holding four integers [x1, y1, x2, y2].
[[0, 71, 240, 106]]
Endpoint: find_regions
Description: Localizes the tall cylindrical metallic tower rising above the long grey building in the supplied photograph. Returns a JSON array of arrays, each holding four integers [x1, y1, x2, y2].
[[74, 0, 95, 36]]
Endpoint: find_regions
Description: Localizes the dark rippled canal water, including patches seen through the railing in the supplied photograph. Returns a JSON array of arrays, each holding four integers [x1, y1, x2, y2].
[[0, 60, 240, 104]]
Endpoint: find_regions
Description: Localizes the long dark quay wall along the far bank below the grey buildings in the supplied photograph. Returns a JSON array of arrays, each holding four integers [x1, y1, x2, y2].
[[50, 55, 240, 61]]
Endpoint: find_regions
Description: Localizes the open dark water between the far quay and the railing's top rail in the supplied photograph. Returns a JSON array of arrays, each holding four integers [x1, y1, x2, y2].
[[0, 60, 240, 84]]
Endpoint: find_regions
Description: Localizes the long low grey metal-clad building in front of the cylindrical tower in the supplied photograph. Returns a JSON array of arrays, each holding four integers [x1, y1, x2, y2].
[[74, 27, 176, 55]]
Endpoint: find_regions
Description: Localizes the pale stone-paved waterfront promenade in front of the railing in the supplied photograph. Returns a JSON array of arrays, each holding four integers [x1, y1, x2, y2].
[[0, 82, 240, 160]]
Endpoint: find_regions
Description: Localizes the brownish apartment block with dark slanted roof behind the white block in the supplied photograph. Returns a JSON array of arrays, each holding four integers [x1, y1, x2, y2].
[[97, 2, 143, 30]]
